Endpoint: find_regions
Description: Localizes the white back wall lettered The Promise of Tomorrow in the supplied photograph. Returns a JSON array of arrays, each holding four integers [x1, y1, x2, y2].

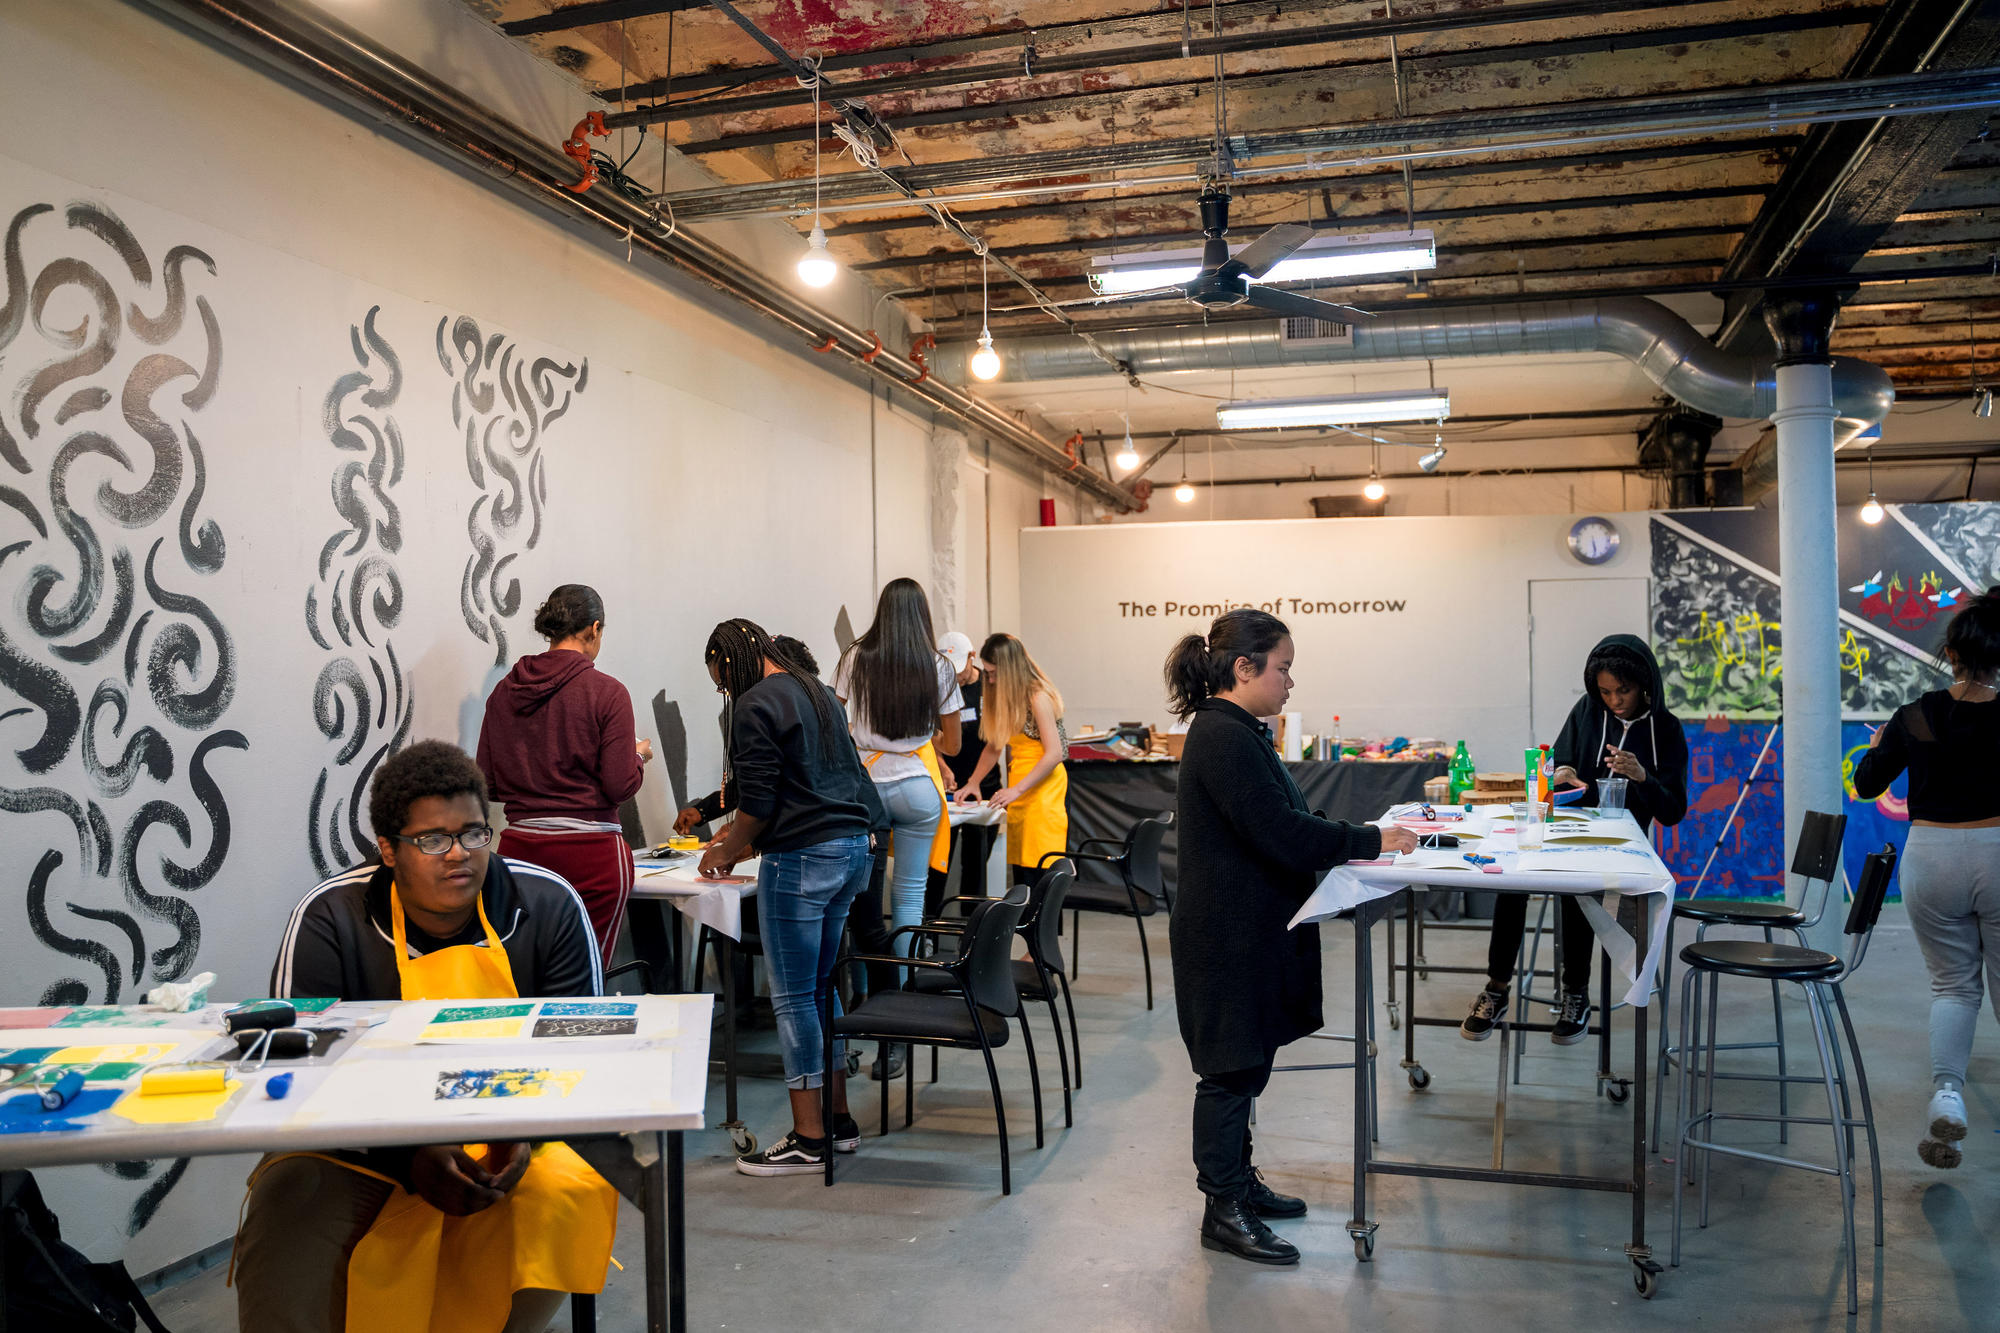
[[1020, 514, 1652, 769]]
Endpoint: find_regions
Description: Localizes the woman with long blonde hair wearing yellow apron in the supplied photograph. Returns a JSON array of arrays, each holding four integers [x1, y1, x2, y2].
[[958, 634, 1070, 883]]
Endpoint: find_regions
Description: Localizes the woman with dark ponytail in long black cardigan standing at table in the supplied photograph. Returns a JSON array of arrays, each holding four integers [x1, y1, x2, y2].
[[1166, 610, 1416, 1263]]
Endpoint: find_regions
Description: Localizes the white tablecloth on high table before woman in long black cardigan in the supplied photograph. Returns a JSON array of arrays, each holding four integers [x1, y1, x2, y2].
[[1292, 807, 1674, 1005]]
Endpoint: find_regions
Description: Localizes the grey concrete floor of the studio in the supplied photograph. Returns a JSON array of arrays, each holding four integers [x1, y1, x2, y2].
[[158, 907, 2000, 1333]]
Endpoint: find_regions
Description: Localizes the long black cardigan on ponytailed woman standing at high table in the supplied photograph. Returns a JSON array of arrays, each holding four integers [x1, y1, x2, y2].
[[1168, 699, 1382, 1075]]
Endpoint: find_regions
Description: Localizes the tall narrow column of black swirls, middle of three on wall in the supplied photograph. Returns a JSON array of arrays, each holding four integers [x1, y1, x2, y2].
[[306, 306, 414, 877]]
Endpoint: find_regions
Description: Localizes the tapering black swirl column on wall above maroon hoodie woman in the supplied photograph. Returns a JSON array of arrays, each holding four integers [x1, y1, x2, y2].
[[436, 314, 590, 667]]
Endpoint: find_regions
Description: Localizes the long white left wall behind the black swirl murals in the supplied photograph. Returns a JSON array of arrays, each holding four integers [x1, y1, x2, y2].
[[0, 0, 1064, 1273]]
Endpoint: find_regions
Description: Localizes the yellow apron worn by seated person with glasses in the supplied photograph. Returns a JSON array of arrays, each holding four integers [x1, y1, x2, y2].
[[346, 885, 618, 1333]]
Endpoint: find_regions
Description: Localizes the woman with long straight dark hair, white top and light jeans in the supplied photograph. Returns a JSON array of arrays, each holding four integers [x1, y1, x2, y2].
[[834, 578, 964, 992]]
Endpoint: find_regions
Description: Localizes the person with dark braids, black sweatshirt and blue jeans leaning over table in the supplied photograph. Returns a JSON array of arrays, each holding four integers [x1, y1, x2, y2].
[[702, 620, 872, 1175]]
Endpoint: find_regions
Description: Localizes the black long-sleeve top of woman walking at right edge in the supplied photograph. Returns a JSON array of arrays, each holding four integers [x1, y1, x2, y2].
[[1854, 691, 2000, 825]]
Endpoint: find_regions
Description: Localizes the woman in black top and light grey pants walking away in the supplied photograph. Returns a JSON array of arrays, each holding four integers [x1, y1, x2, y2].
[[1854, 584, 2000, 1169]]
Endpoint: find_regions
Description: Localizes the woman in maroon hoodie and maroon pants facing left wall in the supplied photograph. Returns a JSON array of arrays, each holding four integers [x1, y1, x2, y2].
[[478, 582, 652, 959]]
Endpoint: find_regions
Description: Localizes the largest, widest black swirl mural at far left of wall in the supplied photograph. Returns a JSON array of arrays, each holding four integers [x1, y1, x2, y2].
[[0, 202, 250, 1233]]
